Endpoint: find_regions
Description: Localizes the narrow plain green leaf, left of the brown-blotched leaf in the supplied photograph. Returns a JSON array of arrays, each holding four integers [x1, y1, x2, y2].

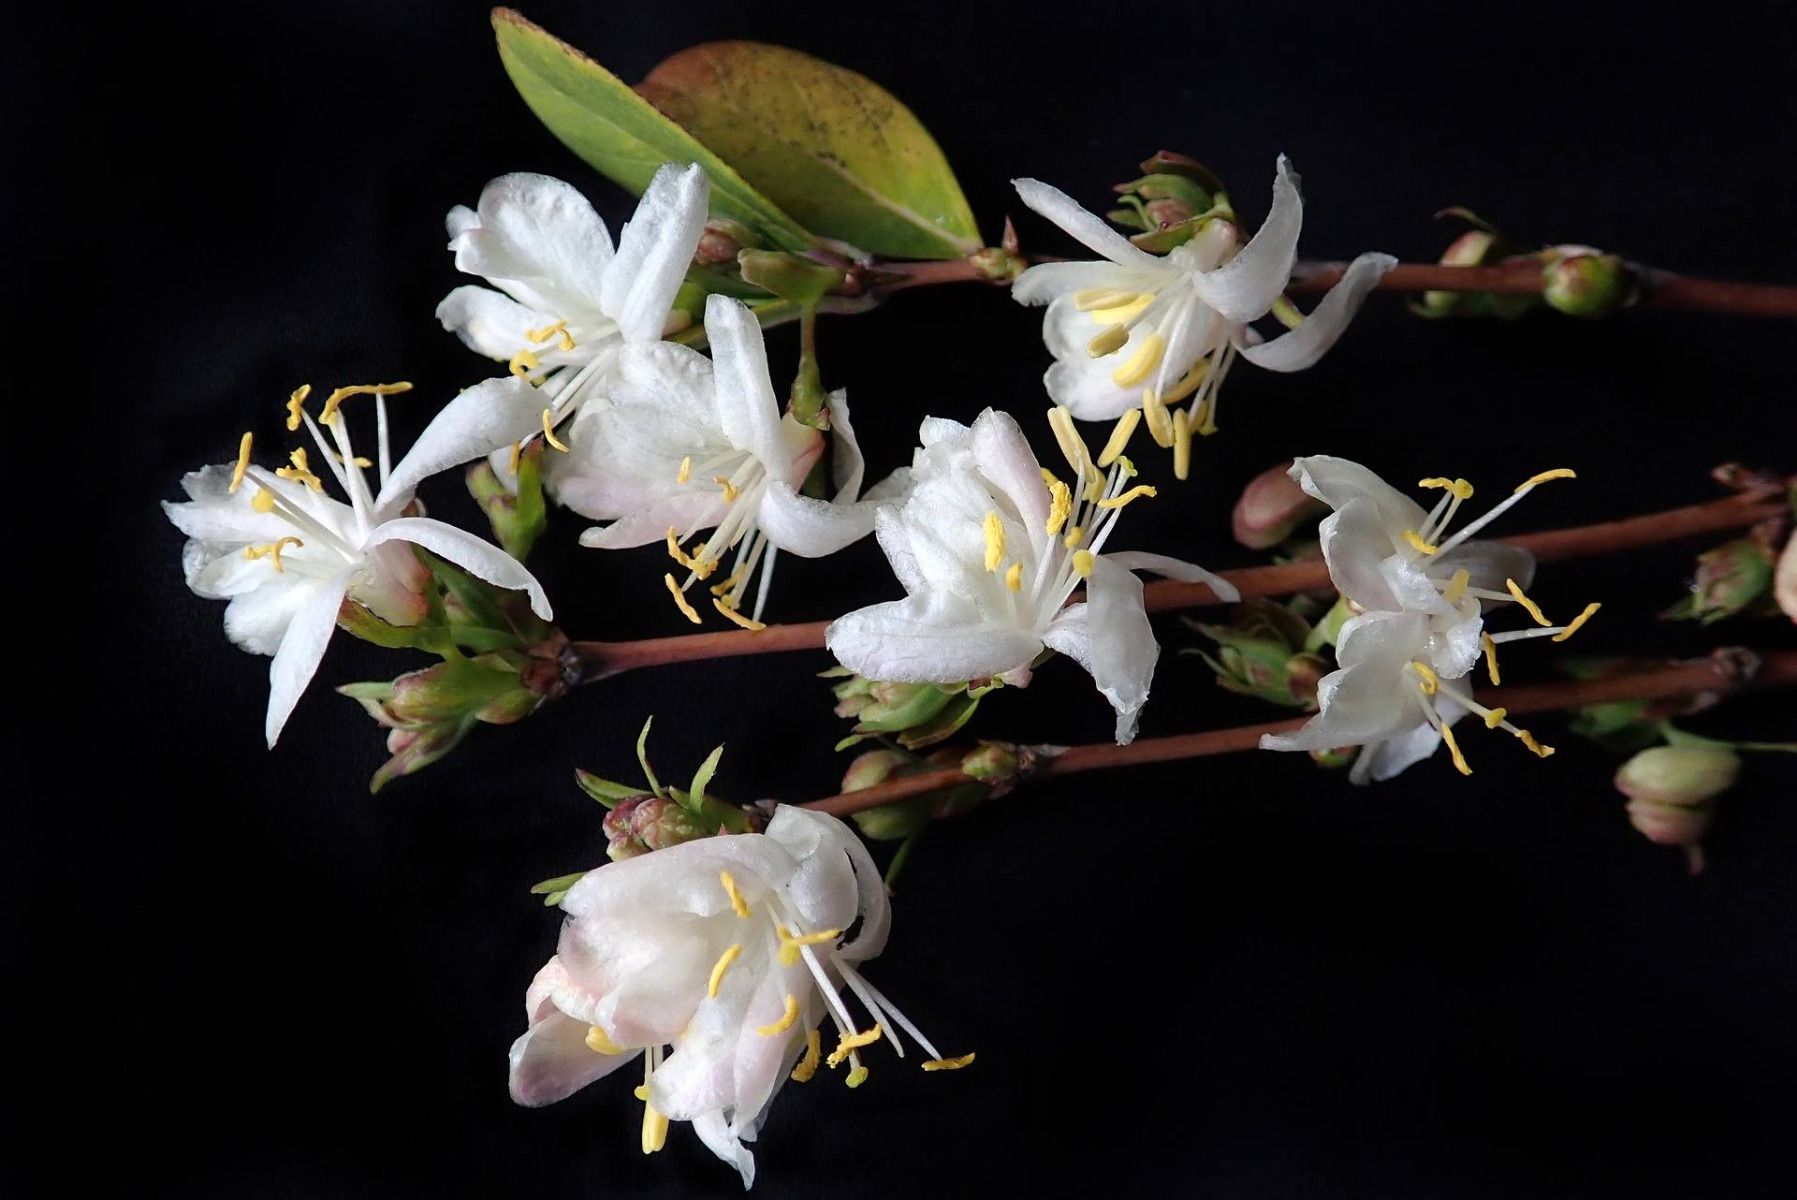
[[492, 9, 816, 250]]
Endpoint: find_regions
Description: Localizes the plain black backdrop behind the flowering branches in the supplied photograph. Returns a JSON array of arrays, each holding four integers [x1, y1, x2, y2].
[[17, 2, 1797, 1198]]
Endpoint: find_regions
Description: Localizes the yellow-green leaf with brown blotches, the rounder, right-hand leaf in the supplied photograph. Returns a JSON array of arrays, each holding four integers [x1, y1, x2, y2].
[[638, 41, 979, 259]]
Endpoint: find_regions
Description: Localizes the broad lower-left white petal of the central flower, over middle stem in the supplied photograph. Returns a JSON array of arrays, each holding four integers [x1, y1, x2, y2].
[[823, 591, 1042, 683]]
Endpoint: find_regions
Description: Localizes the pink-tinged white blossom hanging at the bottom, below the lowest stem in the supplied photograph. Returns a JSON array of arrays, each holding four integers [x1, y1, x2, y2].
[[510, 807, 974, 1187]]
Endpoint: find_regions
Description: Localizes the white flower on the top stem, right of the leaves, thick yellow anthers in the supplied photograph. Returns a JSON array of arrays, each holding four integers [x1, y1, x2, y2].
[[1012, 154, 1396, 463]]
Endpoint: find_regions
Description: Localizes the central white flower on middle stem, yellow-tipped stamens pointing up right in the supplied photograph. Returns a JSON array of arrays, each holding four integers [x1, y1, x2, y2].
[[825, 408, 1238, 742]]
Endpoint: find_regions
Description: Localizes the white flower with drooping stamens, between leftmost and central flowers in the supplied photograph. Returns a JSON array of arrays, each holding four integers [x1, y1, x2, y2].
[[559, 295, 875, 629]]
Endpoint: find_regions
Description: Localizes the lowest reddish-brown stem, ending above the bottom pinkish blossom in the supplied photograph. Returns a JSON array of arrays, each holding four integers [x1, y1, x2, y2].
[[803, 650, 1797, 817]]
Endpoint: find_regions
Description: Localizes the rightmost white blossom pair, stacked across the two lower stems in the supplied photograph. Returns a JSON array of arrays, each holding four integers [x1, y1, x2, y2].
[[1260, 454, 1599, 783]]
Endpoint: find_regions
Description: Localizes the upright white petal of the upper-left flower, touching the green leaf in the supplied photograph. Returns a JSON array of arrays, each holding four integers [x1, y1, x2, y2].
[[600, 163, 712, 341]]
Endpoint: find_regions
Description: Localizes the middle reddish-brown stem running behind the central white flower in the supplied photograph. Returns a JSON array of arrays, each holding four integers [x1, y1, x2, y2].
[[562, 485, 1783, 684]]
